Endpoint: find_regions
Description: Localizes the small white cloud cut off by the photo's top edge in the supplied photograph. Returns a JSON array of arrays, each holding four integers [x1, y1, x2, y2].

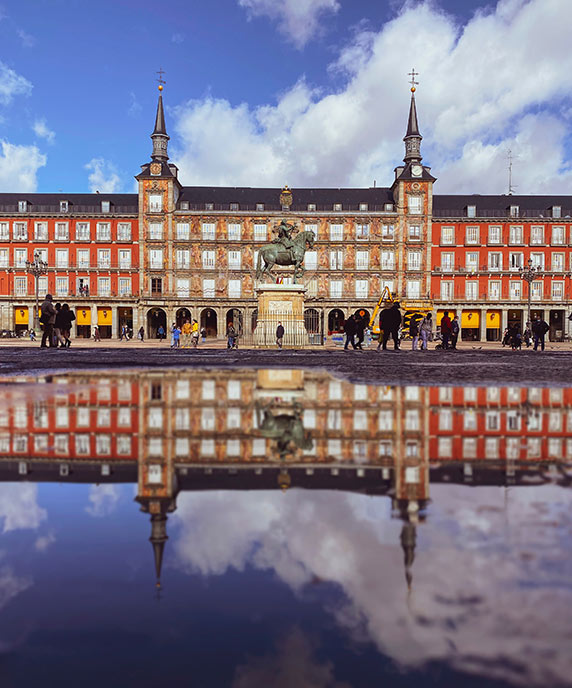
[[238, 0, 340, 48]]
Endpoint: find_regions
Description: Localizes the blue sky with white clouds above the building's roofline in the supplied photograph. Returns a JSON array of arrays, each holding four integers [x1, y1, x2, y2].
[[0, 0, 572, 194]]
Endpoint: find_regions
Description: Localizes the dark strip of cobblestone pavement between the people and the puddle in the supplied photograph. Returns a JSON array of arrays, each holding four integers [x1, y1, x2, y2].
[[0, 342, 572, 386]]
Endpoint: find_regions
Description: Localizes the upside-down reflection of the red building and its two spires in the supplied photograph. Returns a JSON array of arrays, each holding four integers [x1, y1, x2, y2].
[[0, 370, 572, 586]]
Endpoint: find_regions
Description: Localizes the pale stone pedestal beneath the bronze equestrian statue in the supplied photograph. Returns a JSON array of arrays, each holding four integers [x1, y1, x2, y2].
[[254, 284, 309, 349]]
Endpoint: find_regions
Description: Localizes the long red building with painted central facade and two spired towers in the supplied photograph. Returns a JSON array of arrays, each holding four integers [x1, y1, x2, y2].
[[0, 88, 572, 341]]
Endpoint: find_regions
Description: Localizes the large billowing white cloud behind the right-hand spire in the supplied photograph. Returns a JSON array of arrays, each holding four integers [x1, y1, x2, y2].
[[173, 0, 572, 193]]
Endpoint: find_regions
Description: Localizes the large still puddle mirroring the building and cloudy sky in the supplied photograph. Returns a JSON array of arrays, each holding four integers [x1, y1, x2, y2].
[[0, 369, 572, 688]]
